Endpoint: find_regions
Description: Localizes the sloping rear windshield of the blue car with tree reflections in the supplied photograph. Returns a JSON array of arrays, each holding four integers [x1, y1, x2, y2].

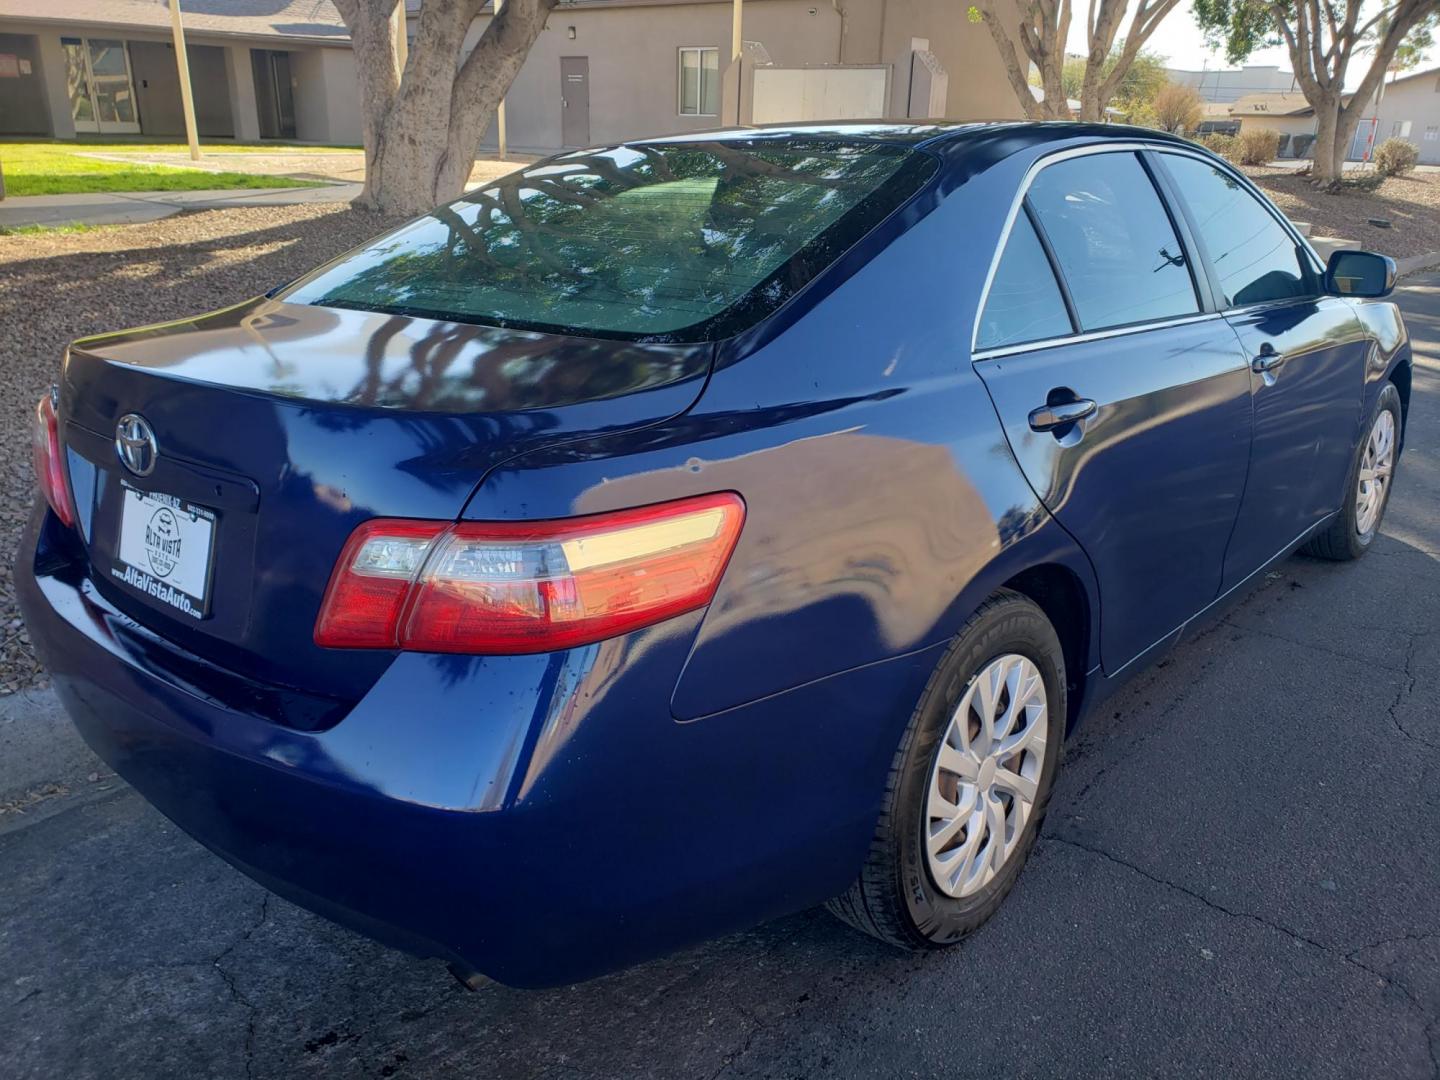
[[284, 138, 935, 341]]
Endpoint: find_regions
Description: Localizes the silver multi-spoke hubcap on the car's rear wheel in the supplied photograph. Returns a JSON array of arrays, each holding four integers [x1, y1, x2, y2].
[[924, 652, 1048, 897]]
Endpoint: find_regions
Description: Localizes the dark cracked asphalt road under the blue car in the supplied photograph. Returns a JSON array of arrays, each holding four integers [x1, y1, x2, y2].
[[0, 275, 1440, 1080]]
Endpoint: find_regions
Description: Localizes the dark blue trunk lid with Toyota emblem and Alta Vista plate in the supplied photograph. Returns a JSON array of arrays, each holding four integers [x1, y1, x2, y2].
[[60, 300, 711, 714]]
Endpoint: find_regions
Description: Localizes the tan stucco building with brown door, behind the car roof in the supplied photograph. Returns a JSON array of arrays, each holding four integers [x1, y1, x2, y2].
[[446, 0, 1021, 150]]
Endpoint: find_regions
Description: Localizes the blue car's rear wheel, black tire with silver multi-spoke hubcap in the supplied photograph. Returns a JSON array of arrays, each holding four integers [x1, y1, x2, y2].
[[829, 590, 1066, 949]]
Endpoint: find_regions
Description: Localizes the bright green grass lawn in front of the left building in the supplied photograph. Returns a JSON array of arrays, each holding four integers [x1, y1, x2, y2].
[[0, 140, 334, 196]]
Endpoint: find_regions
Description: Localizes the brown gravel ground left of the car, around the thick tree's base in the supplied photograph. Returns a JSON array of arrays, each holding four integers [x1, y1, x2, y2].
[[0, 204, 406, 693]]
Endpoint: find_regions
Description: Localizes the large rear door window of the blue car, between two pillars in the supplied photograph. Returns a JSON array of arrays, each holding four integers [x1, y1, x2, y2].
[[1030, 154, 1200, 330]]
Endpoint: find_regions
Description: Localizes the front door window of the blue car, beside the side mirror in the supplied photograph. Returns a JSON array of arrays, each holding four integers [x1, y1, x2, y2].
[[1165, 154, 1313, 307]]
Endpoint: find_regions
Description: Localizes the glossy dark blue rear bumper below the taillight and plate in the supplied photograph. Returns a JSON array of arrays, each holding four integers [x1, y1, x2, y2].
[[16, 514, 937, 986]]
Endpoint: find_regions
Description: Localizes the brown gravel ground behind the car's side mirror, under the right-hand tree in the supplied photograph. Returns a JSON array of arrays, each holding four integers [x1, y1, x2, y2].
[[1246, 168, 1440, 259]]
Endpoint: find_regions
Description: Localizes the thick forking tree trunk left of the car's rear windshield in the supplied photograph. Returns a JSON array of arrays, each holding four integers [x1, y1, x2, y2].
[[336, 0, 556, 216]]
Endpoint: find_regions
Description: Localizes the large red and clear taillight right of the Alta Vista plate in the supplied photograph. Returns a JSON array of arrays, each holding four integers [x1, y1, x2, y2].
[[315, 492, 744, 654]]
